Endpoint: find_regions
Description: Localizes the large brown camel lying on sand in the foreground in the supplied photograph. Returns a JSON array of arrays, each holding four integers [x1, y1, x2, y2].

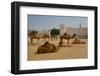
[[37, 42, 58, 54]]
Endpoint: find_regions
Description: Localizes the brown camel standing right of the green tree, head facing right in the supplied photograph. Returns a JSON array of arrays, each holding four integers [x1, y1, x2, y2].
[[59, 33, 76, 46]]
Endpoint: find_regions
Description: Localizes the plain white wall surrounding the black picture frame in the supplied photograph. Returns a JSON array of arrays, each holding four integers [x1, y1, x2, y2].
[[0, 0, 100, 76]]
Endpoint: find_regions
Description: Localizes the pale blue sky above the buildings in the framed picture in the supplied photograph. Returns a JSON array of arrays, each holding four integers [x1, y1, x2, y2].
[[28, 15, 88, 31]]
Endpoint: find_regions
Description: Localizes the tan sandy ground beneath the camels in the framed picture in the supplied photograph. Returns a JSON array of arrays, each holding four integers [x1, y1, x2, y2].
[[28, 39, 88, 61]]
